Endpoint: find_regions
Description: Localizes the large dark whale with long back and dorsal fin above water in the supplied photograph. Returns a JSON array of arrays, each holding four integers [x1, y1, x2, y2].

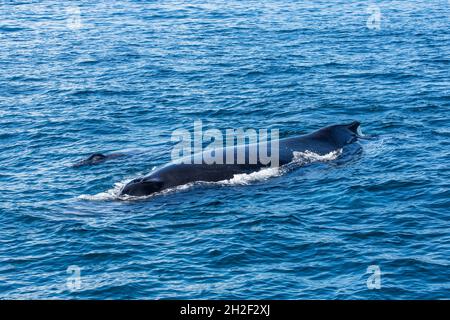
[[120, 121, 361, 197]]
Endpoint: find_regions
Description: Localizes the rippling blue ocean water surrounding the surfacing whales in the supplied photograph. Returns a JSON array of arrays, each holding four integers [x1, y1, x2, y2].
[[0, 0, 450, 299]]
